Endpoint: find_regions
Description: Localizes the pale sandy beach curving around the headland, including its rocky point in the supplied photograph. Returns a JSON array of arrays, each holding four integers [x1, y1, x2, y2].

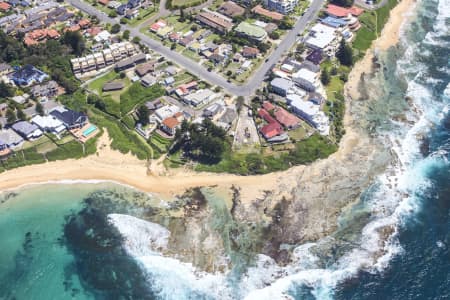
[[0, 0, 414, 227]]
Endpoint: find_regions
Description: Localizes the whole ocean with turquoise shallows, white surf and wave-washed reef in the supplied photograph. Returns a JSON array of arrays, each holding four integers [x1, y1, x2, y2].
[[0, 0, 450, 300]]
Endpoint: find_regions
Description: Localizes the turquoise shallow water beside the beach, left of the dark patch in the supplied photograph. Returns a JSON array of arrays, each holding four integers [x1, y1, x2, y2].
[[0, 184, 114, 299]]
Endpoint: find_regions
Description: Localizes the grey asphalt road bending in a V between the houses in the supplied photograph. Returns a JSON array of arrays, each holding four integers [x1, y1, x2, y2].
[[67, 0, 325, 96]]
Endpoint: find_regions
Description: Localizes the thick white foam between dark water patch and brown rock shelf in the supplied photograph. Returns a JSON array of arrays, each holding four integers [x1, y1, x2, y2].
[[108, 214, 231, 300]]
